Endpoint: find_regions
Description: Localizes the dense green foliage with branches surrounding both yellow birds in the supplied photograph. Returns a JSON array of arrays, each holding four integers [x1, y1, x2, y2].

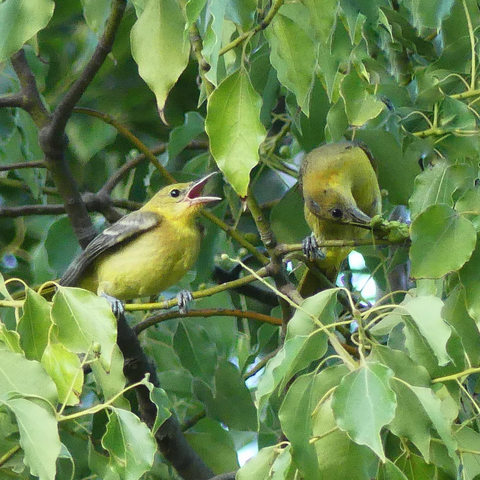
[[0, 0, 480, 480]]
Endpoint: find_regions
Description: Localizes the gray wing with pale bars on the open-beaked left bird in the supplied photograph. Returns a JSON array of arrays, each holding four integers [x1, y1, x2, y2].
[[59, 211, 162, 287]]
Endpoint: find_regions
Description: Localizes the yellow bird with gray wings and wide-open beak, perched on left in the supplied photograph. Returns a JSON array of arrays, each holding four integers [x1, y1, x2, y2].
[[59, 173, 221, 312]]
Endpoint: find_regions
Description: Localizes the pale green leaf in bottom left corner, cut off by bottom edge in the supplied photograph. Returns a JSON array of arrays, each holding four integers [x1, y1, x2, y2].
[[4, 398, 61, 480]]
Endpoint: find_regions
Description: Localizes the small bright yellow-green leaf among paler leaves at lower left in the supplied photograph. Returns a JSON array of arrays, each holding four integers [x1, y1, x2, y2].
[[42, 343, 83, 405]]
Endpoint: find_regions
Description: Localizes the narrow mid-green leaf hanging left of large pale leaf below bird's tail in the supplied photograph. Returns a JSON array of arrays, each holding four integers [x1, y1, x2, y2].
[[17, 288, 52, 361]]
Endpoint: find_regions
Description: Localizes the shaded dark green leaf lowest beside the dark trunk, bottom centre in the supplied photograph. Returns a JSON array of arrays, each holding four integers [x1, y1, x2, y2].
[[185, 418, 238, 474]]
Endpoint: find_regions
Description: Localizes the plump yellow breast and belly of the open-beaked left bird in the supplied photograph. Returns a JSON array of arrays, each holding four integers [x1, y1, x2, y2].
[[80, 218, 201, 300]]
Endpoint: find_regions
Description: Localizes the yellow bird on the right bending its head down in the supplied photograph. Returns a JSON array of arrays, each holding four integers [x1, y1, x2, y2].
[[300, 142, 381, 282]]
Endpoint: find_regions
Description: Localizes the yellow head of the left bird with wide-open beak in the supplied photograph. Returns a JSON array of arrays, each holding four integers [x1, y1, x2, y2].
[[146, 172, 221, 217]]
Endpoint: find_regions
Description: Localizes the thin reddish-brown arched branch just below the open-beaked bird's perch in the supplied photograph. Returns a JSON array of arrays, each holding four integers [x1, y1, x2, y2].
[[133, 308, 282, 335]]
